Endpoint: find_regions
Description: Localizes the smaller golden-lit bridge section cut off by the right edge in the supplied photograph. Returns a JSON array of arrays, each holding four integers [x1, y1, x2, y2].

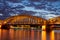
[[47, 16, 60, 30]]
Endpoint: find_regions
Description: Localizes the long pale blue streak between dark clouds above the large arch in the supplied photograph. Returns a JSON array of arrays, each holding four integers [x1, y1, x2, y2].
[[21, 6, 55, 13]]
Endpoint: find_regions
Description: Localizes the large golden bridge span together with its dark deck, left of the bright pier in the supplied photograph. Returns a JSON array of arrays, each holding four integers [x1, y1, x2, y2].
[[2, 15, 47, 28]]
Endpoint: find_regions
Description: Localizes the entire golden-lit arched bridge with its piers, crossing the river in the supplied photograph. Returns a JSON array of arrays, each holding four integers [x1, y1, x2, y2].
[[1, 15, 60, 30]]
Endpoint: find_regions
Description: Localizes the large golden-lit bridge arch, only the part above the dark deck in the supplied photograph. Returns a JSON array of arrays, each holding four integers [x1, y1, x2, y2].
[[4, 15, 47, 25]]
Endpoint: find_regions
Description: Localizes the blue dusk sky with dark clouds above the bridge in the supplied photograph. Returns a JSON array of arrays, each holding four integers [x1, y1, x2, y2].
[[0, 0, 60, 19]]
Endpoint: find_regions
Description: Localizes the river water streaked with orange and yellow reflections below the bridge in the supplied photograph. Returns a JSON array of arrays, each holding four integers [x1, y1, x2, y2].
[[0, 29, 60, 40]]
